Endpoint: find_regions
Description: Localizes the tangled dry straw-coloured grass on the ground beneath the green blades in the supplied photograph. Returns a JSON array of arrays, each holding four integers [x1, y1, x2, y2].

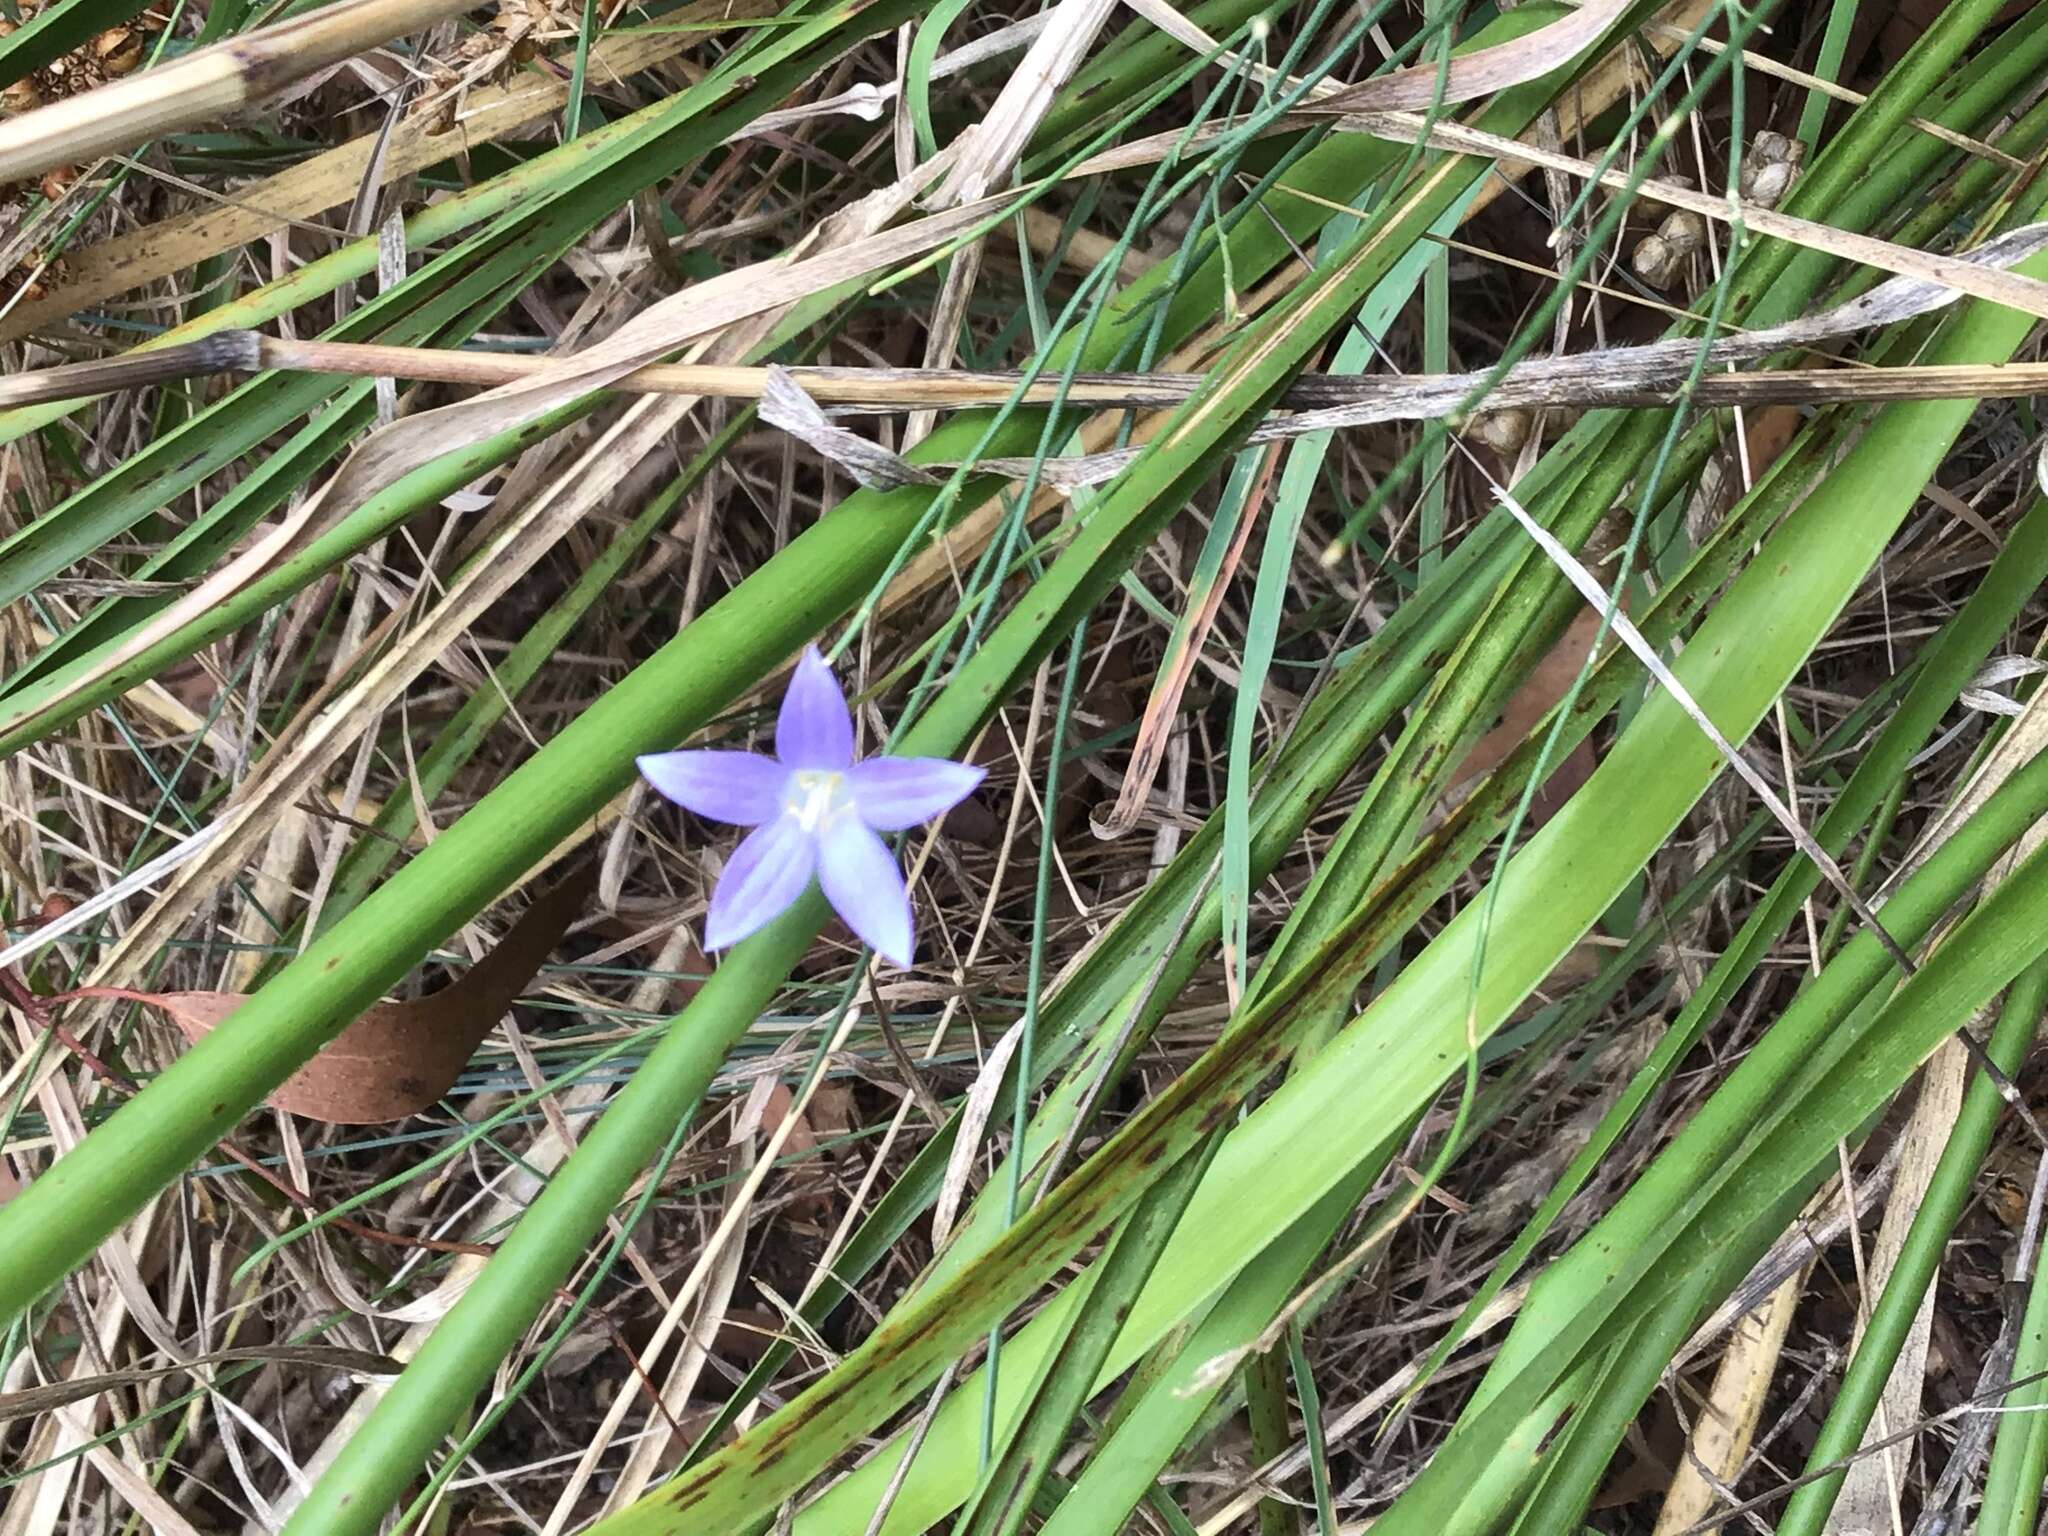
[[12, 0, 2048, 1536]]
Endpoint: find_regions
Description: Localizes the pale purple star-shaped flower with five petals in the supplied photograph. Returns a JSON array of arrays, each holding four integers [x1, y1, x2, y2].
[[639, 645, 983, 967]]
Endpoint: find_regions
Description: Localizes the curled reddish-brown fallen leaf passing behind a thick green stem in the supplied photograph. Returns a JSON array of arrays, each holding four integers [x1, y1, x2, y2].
[[64, 860, 596, 1124]]
